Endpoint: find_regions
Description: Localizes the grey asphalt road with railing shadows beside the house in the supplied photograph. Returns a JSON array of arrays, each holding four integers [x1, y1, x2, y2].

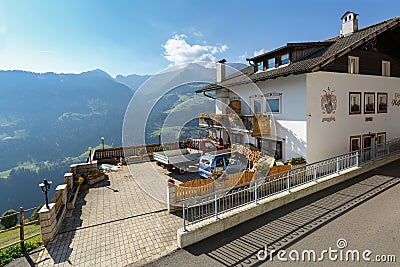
[[149, 161, 400, 267]]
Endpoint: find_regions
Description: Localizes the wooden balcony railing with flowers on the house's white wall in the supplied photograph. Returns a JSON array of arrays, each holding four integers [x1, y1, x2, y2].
[[199, 114, 271, 136]]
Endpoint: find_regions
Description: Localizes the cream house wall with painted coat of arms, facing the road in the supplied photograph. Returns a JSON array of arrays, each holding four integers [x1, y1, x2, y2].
[[306, 72, 400, 162]]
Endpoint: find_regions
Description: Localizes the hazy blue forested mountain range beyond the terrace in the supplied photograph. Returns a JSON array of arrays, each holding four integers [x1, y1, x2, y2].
[[0, 62, 247, 213]]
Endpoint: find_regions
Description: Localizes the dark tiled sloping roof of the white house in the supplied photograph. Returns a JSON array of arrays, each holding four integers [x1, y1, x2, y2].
[[196, 17, 400, 92]]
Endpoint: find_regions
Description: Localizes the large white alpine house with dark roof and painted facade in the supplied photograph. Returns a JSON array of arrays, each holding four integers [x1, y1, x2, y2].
[[197, 12, 400, 163]]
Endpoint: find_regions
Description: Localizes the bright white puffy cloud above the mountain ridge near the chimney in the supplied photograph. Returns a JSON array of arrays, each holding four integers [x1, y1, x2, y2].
[[162, 34, 228, 65]]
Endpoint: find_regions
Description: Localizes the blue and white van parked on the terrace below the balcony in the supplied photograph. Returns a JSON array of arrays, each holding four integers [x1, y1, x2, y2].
[[199, 150, 246, 179]]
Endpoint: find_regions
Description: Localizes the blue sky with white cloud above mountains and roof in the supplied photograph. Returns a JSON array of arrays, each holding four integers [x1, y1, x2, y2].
[[0, 0, 400, 76]]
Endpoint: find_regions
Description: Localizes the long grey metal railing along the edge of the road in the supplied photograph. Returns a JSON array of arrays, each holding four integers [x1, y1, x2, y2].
[[181, 139, 400, 231]]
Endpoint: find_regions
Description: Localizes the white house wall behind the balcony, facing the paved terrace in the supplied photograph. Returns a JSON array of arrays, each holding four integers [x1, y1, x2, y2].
[[229, 74, 307, 160]]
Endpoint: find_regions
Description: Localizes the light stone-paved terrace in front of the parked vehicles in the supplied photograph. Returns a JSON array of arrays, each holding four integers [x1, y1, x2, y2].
[[36, 164, 182, 266]]
